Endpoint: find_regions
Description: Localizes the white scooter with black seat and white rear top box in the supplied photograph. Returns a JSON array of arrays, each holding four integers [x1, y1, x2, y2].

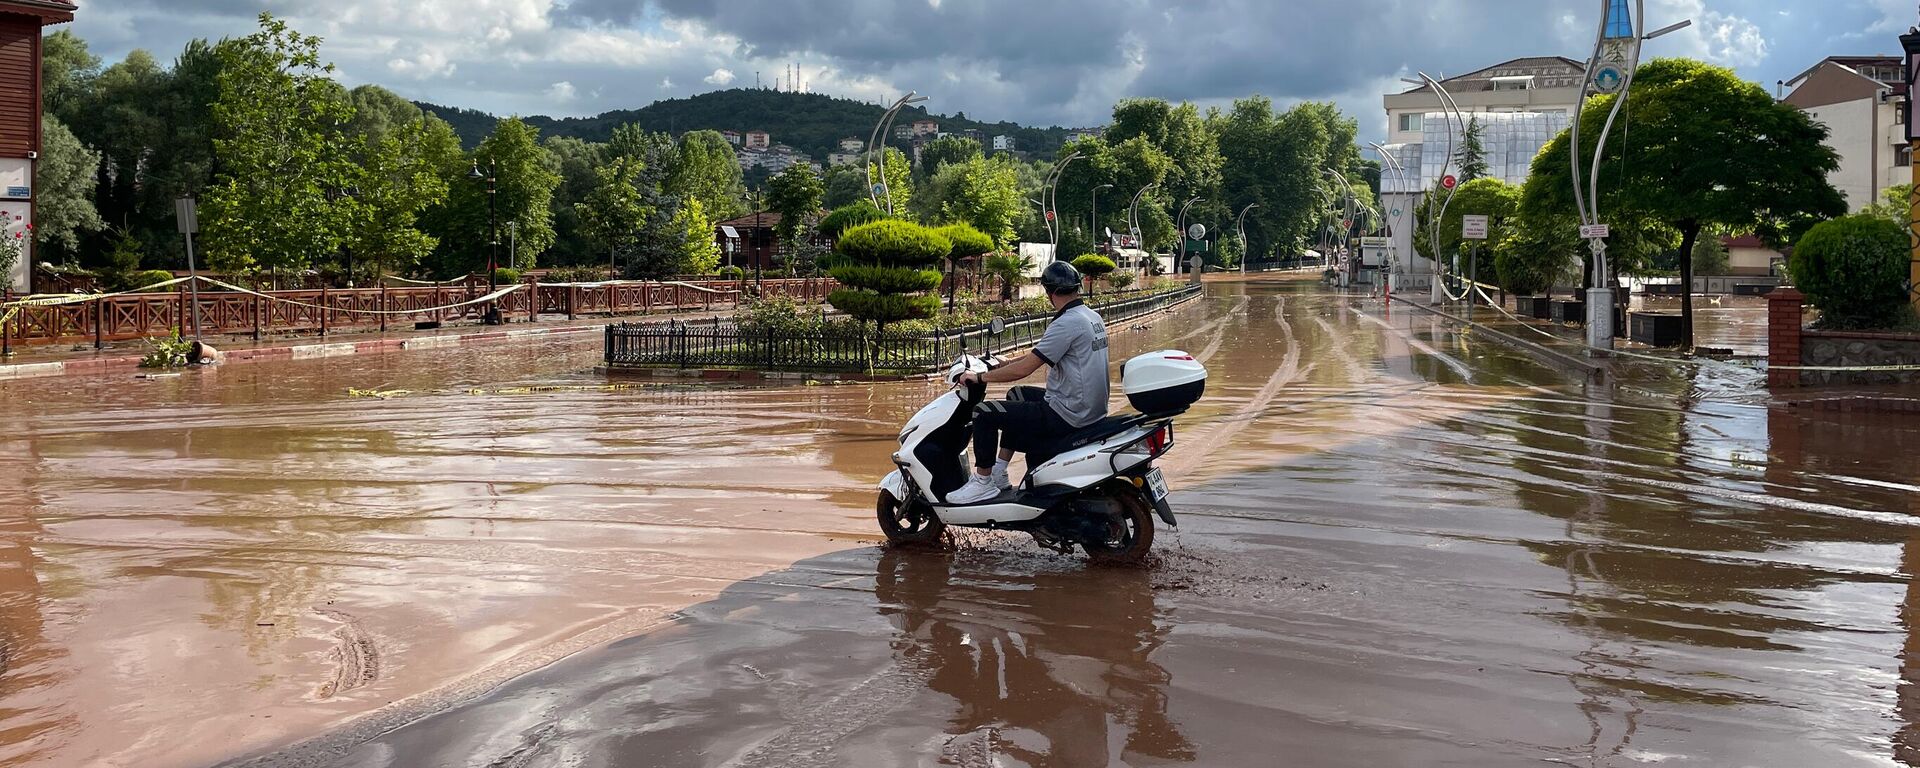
[[876, 341, 1206, 564]]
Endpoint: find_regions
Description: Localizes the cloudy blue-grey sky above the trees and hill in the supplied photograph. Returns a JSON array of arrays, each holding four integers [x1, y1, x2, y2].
[[73, 0, 1920, 136]]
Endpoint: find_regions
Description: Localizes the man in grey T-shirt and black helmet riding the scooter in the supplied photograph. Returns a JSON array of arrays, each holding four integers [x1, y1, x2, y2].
[[947, 261, 1110, 505]]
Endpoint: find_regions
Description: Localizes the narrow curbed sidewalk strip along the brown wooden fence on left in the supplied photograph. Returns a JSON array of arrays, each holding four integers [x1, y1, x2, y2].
[[0, 309, 733, 382]]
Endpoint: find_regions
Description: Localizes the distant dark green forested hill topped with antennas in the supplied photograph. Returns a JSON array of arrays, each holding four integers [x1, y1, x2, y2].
[[419, 88, 1068, 161]]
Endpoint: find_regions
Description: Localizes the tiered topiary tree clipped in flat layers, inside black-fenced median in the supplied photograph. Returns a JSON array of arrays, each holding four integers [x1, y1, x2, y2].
[[828, 219, 952, 328]]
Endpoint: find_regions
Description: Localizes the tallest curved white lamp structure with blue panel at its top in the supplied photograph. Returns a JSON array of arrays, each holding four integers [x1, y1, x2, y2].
[[1567, 0, 1693, 357]]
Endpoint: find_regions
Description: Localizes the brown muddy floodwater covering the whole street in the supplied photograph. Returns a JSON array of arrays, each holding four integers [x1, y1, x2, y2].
[[0, 282, 1920, 768]]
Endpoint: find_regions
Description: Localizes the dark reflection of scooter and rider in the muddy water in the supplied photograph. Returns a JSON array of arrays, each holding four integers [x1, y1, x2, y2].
[[876, 551, 1194, 766]]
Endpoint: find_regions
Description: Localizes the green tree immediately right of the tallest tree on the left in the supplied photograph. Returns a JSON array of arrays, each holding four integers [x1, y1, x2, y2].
[[342, 115, 461, 280]]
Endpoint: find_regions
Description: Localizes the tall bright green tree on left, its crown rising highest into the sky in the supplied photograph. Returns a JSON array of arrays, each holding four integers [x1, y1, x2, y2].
[[202, 13, 353, 273]]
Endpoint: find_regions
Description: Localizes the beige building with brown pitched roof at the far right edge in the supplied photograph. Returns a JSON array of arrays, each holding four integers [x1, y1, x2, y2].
[[1784, 56, 1912, 211]]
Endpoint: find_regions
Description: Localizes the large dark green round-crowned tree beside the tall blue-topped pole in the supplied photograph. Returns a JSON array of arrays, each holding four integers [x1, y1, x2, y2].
[[1526, 60, 1847, 346]]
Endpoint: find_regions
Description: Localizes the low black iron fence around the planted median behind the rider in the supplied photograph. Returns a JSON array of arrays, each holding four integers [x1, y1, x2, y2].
[[605, 286, 1200, 372]]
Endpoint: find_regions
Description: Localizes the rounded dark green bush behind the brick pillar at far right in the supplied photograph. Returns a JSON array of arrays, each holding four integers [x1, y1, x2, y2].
[[1788, 215, 1914, 330]]
